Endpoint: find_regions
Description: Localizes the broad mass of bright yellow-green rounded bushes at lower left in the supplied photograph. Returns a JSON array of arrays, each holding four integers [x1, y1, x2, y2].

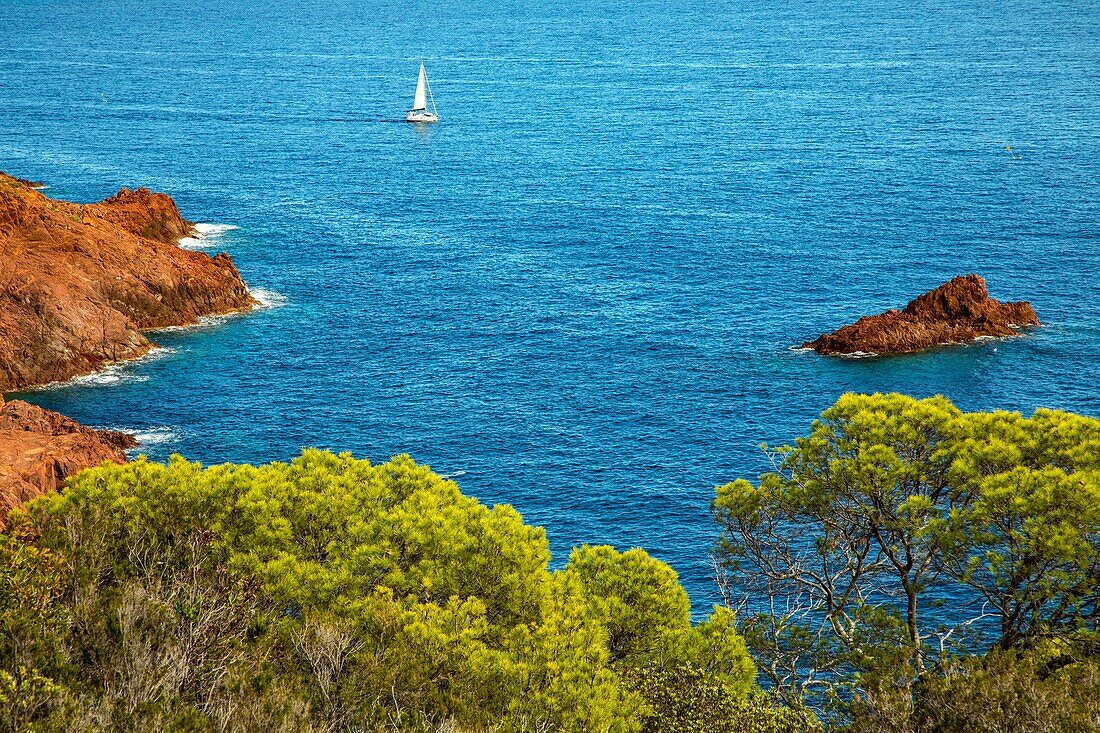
[[0, 450, 754, 733]]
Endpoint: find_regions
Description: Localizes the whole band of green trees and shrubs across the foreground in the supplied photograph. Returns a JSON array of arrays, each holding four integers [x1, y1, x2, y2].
[[0, 394, 1100, 733]]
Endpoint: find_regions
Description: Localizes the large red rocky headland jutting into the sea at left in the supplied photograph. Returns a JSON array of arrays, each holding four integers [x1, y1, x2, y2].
[[0, 174, 255, 392]]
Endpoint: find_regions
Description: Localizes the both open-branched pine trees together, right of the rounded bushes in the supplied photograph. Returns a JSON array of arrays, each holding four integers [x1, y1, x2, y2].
[[713, 394, 1100, 717]]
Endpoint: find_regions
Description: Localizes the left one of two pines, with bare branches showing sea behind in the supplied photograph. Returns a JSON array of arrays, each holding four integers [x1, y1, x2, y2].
[[714, 395, 960, 708]]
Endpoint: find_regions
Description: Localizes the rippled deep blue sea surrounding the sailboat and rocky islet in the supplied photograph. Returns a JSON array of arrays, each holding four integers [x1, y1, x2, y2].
[[0, 0, 1100, 611]]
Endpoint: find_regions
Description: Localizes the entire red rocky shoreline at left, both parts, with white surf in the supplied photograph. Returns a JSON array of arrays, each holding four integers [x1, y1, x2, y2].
[[0, 173, 264, 508]]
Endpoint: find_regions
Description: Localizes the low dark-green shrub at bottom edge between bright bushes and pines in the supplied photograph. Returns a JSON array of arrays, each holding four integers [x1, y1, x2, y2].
[[628, 665, 821, 733]]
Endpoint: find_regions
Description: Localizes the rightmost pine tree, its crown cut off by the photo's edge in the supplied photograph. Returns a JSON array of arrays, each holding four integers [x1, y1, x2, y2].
[[944, 409, 1100, 648]]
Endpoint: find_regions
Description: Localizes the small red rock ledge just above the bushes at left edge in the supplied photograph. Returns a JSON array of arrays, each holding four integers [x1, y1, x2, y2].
[[0, 397, 138, 519]]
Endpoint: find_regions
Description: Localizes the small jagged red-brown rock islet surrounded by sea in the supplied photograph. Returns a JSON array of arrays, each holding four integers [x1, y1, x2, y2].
[[803, 275, 1038, 354]]
